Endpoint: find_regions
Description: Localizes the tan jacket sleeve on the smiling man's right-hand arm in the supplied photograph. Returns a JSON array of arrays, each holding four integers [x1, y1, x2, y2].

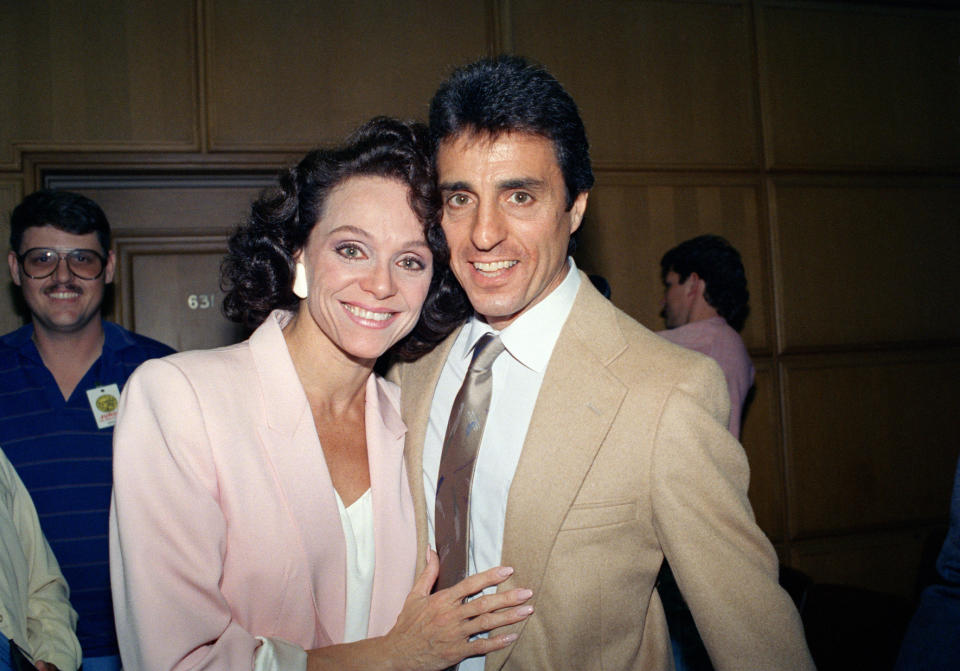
[[651, 359, 813, 670]]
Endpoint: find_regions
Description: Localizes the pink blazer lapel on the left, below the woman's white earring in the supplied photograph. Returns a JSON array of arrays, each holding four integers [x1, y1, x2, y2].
[[250, 313, 346, 645]]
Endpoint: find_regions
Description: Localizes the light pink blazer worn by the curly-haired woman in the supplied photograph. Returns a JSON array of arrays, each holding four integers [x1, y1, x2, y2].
[[110, 312, 417, 671]]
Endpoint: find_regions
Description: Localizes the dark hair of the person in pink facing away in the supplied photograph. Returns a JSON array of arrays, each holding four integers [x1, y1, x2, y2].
[[660, 235, 750, 331]]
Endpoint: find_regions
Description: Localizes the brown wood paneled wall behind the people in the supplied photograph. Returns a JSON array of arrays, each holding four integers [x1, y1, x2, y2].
[[0, 0, 960, 596]]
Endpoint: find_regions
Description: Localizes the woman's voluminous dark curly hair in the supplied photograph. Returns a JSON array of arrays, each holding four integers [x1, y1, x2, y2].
[[220, 117, 470, 360]]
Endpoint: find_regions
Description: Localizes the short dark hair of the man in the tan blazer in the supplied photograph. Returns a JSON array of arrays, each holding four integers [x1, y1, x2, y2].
[[430, 55, 593, 253]]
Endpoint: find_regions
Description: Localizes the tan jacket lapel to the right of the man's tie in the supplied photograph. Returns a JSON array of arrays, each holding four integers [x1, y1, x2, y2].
[[485, 277, 626, 669]]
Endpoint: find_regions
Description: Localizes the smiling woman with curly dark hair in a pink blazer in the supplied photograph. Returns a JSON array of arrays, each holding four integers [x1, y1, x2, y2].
[[110, 117, 532, 671]]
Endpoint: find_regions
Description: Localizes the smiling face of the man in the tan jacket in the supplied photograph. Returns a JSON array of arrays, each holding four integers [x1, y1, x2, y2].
[[437, 132, 587, 329]]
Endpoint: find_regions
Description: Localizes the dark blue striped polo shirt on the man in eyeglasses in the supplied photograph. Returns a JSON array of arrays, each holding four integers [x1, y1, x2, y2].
[[0, 321, 174, 657]]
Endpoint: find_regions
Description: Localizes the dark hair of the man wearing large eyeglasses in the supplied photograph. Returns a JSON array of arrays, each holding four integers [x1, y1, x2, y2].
[[10, 189, 110, 254]]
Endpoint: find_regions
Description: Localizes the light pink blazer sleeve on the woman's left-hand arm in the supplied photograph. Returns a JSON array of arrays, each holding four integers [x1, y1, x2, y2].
[[110, 360, 262, 671]]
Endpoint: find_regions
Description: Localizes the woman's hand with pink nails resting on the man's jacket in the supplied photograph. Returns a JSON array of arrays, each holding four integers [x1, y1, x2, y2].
[[383, 550, 533, 671]]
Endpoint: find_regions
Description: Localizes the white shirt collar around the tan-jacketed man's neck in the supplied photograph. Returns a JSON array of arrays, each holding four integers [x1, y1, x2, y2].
[[452, 257, 580, 373]]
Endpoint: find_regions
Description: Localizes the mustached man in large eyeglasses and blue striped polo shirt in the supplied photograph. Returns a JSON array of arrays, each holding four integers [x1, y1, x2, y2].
[[0, 190, 173, 671]]
